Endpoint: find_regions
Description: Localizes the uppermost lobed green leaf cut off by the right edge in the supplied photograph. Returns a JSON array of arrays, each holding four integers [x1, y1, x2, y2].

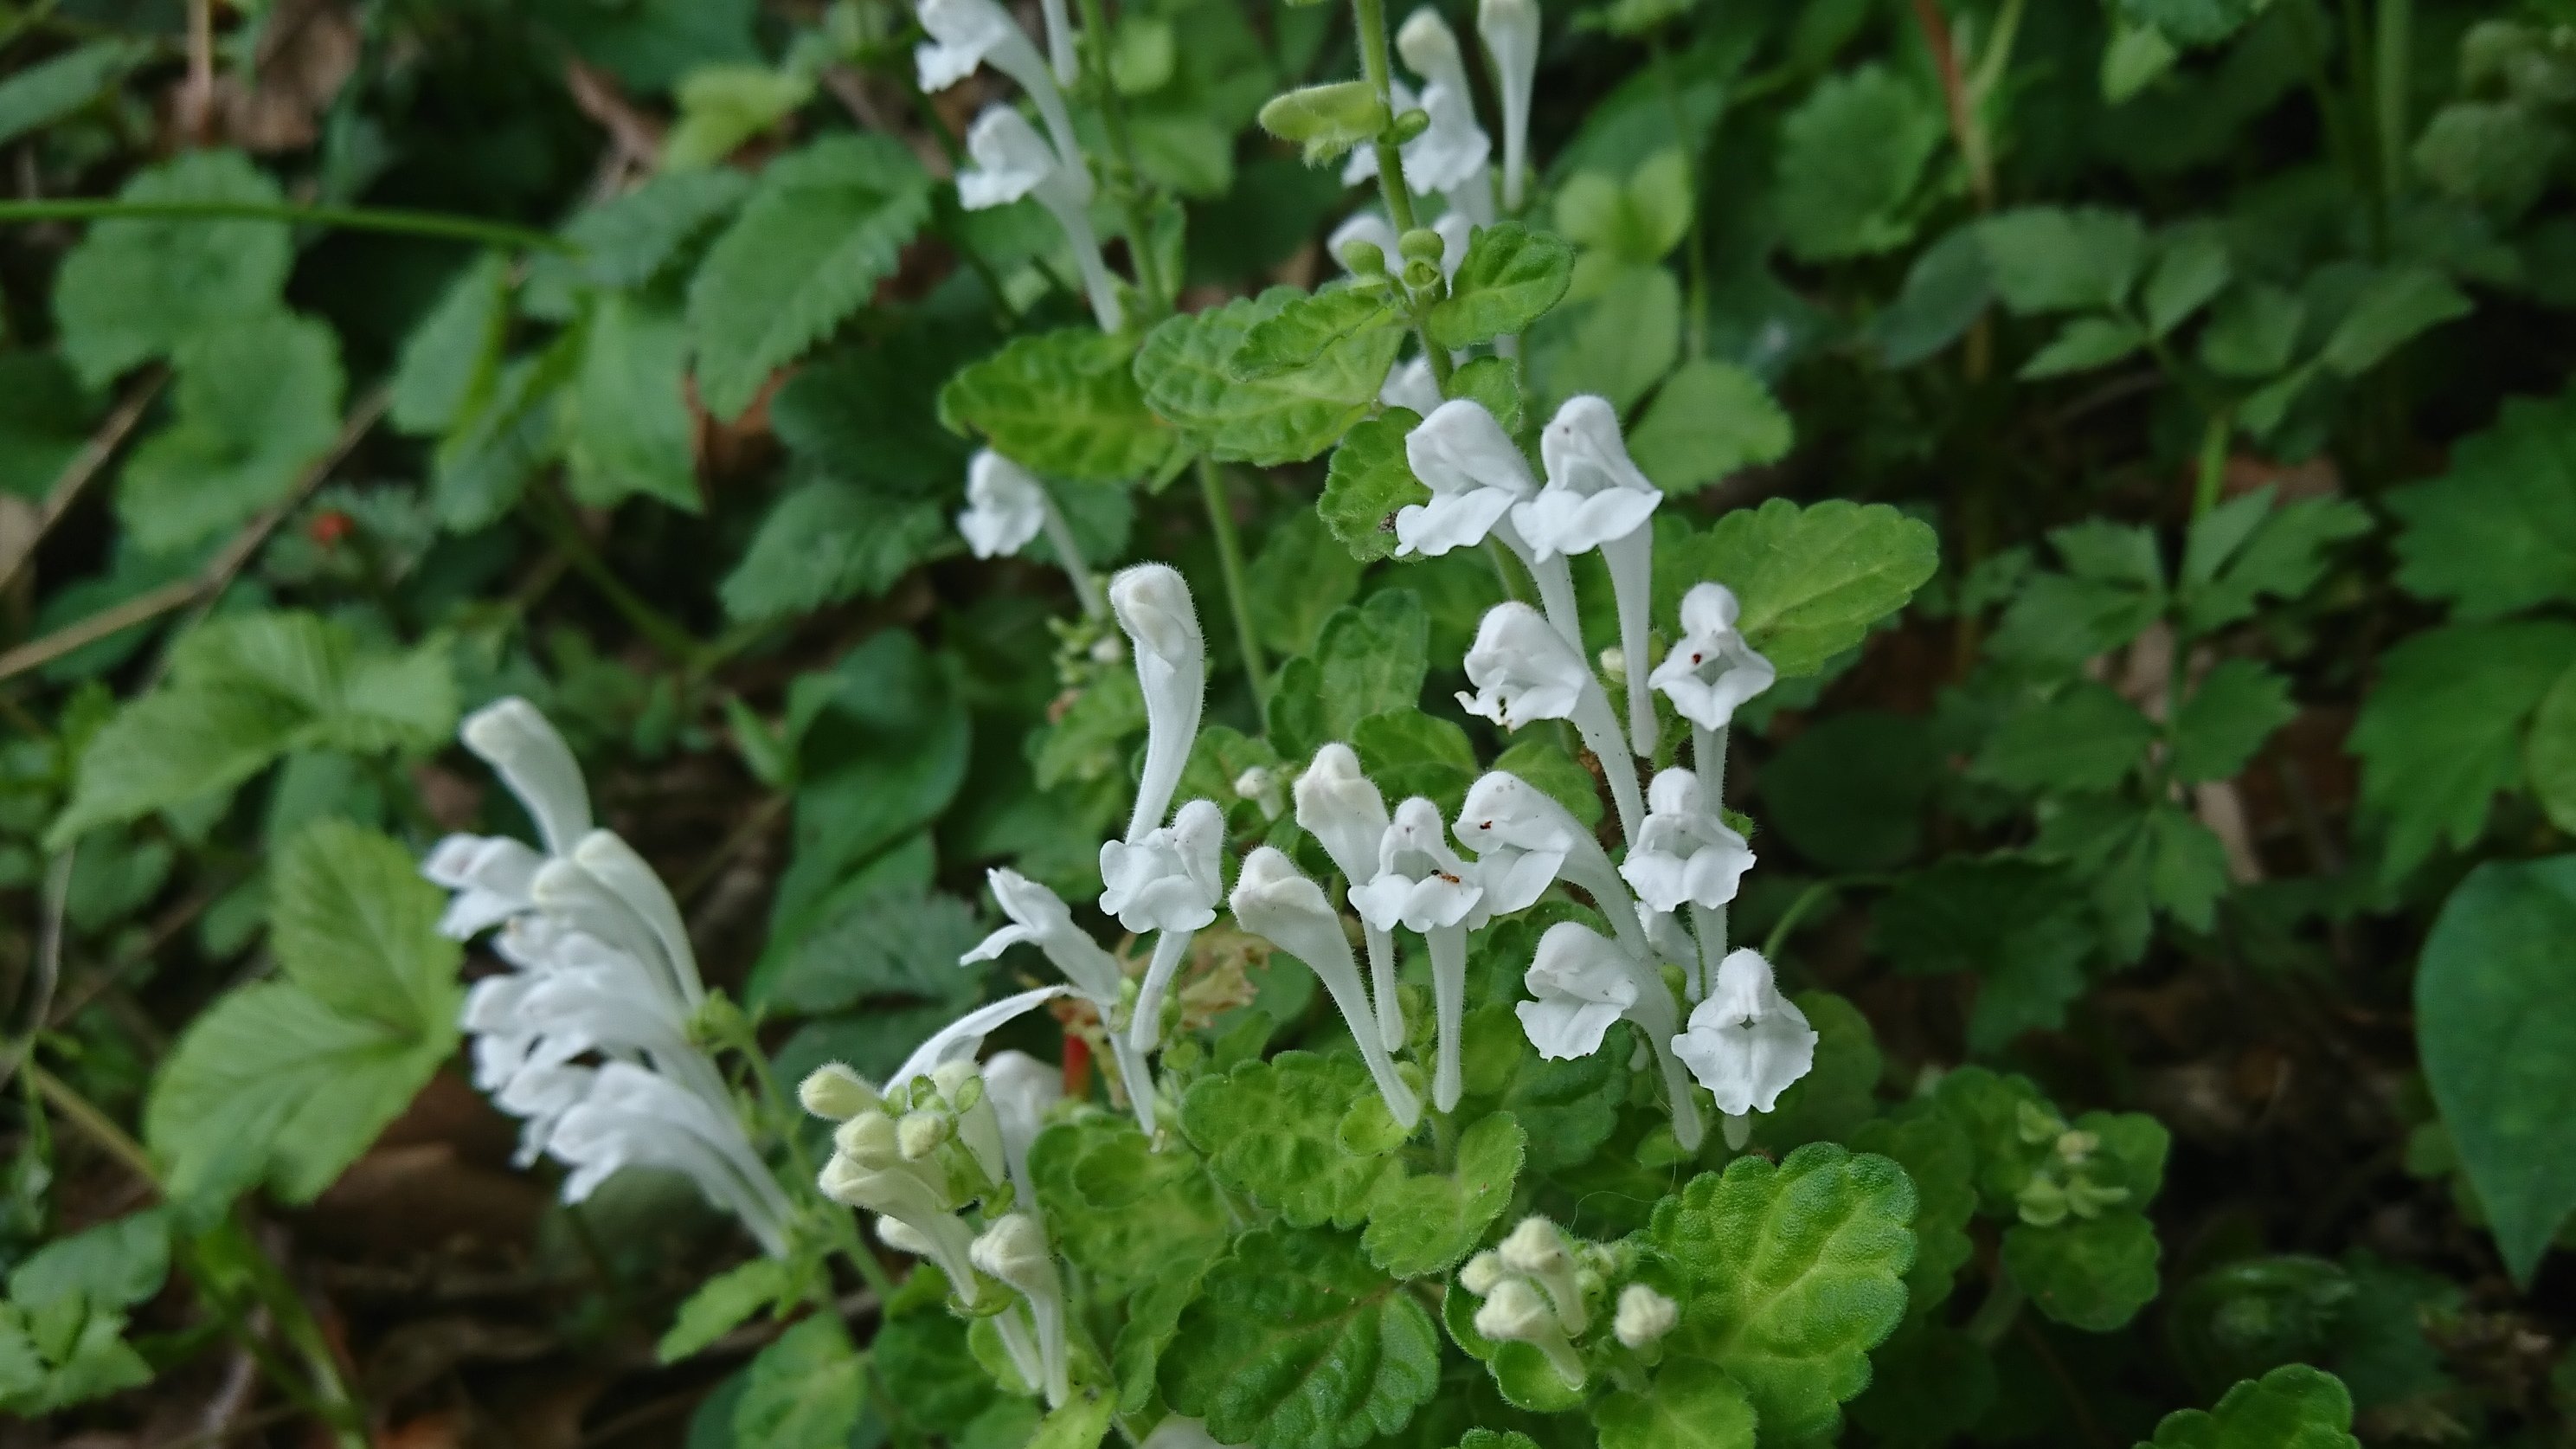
[[2388, 390, 2576, 619]]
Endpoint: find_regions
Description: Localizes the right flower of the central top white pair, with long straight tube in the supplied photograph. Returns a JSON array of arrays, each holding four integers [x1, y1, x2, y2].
[[1512, 395, 1664, 758]]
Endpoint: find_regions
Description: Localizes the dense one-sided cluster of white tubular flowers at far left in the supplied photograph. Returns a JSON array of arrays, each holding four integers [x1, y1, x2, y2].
[[422, 699, 793, 1253]]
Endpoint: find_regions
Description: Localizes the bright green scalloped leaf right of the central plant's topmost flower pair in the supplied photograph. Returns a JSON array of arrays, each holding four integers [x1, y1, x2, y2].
[[1654, 498, 1940, 678]]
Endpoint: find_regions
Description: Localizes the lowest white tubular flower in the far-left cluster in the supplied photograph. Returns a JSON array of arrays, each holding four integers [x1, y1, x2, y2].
[[546, 1062, 793, 1256]]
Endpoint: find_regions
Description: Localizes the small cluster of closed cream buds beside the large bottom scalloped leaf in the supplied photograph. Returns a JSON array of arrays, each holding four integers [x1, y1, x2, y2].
[[1458, 1217, 1682, 1388]]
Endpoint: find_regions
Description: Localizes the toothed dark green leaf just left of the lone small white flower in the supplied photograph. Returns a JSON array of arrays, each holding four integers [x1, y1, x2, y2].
[[716, 477, 953, 621]]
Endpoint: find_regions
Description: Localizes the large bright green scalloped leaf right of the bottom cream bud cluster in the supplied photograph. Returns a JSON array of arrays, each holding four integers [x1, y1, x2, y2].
[[1646, 1143, 1914, 1441]]
